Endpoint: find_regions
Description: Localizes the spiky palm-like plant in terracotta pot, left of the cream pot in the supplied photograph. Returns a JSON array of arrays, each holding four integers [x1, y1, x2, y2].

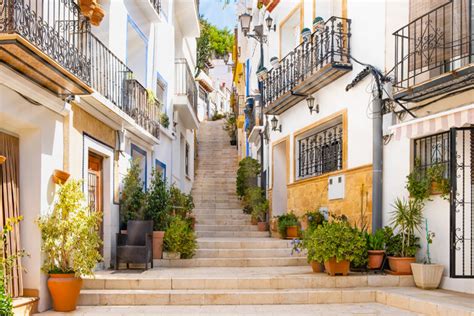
[[387, 198, 423, 274]]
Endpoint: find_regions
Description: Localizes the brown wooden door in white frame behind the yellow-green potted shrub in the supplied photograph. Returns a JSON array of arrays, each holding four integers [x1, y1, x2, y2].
[[87, 152, 104, 255]]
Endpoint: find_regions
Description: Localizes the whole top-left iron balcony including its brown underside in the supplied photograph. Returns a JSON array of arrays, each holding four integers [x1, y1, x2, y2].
[[0, 0, 91, 95]]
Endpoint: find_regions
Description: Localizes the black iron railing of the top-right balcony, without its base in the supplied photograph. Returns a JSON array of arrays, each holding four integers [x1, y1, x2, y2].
[[393, 0, 474, 89]]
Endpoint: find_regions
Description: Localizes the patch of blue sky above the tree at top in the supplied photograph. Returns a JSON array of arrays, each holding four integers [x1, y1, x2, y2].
[[199, 0, 237, 31]]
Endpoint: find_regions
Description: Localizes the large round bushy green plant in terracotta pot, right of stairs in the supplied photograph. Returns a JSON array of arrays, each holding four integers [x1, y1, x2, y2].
[[312, 221, 367, 276]]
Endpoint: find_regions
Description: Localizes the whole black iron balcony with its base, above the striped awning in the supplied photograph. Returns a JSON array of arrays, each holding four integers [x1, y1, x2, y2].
[[393, 0, 474, 102]]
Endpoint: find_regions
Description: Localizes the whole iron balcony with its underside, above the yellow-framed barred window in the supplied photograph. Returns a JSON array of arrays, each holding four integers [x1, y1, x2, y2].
[[263, 17, 352, 114]]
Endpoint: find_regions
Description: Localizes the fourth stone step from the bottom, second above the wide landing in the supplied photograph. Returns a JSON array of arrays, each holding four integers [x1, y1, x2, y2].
[[194, 248, 305, 258]]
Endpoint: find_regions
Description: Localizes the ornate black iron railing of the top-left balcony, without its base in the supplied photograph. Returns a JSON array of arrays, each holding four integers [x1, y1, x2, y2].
[[0, 0, 91, 85]]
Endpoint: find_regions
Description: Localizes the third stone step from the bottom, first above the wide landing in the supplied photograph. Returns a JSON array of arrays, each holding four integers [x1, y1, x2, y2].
[[153, 256, 308, 268]]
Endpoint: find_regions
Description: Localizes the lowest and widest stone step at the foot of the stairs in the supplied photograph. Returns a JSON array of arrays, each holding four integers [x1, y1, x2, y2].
[[79, 288, 377, 306]]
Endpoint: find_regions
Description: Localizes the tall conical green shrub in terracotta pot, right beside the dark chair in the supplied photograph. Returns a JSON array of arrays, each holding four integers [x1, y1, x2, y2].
[[143, 169, 170, 259]]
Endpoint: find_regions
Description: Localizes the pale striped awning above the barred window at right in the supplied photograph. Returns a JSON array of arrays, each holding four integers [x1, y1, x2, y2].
[[390, 104, 474, 140]]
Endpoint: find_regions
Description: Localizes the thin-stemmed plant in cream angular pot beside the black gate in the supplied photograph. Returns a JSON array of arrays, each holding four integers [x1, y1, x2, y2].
[[411, 219, 444, 290]]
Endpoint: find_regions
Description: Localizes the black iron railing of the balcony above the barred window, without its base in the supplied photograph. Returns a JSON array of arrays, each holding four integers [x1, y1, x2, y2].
[[263, 17, 351, 106]]
